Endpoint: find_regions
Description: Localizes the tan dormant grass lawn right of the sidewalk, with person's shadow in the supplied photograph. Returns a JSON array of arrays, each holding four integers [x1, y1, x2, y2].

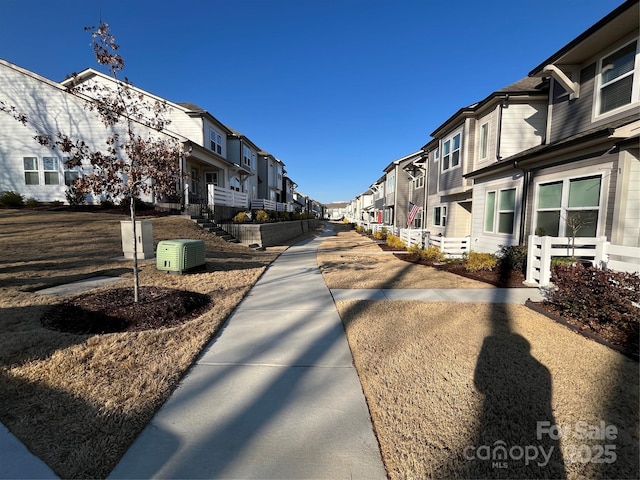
[[318, 226, 639, 480]]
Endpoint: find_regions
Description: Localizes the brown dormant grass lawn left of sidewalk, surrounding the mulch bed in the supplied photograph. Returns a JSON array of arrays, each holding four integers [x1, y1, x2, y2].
[[0, 210, 276, 478]]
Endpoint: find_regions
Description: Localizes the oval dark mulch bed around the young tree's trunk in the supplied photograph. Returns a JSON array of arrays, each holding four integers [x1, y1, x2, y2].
[[40, 287, 211, 334]]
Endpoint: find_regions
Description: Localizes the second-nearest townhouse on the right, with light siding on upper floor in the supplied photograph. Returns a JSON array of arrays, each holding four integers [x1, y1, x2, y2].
[[423, 78, 547, 244]]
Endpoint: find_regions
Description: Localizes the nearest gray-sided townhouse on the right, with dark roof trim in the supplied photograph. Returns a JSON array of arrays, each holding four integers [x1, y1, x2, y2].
[[465, 0, 640, 252]]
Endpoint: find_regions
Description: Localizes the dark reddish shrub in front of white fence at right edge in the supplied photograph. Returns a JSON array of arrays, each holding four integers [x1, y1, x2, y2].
[[545, 264, 640, 331]]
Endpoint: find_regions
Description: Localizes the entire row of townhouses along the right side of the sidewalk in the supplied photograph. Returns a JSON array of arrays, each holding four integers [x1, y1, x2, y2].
[[348, 0, 640, 253]]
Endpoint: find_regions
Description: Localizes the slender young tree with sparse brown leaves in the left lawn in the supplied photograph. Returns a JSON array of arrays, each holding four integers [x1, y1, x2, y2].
[[0, 21, 181, 303]]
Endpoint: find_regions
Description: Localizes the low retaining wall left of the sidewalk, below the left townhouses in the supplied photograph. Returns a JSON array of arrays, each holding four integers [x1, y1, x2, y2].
[[218, 218, 320, 247]]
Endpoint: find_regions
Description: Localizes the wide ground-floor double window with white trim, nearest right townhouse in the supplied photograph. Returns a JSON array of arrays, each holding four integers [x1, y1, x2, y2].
[[535, 175, 602, 237]]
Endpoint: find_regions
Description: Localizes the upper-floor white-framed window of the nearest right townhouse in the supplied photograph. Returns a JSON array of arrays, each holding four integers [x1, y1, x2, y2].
[[596, 41, 639, 115]]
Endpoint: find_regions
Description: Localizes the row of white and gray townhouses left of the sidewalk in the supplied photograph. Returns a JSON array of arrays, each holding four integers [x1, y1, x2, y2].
[[0, 59, 322, 220]]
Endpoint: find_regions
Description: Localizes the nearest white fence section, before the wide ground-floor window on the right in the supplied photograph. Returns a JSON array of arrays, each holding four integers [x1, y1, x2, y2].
[[526, 235, 640, 287]]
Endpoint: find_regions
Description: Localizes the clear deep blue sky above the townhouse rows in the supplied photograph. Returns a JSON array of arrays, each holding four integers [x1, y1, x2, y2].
[[0, 0, 623, 203]]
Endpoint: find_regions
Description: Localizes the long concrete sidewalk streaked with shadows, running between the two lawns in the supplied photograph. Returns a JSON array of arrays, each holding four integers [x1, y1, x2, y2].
[[110, 225, 386, 479]]
